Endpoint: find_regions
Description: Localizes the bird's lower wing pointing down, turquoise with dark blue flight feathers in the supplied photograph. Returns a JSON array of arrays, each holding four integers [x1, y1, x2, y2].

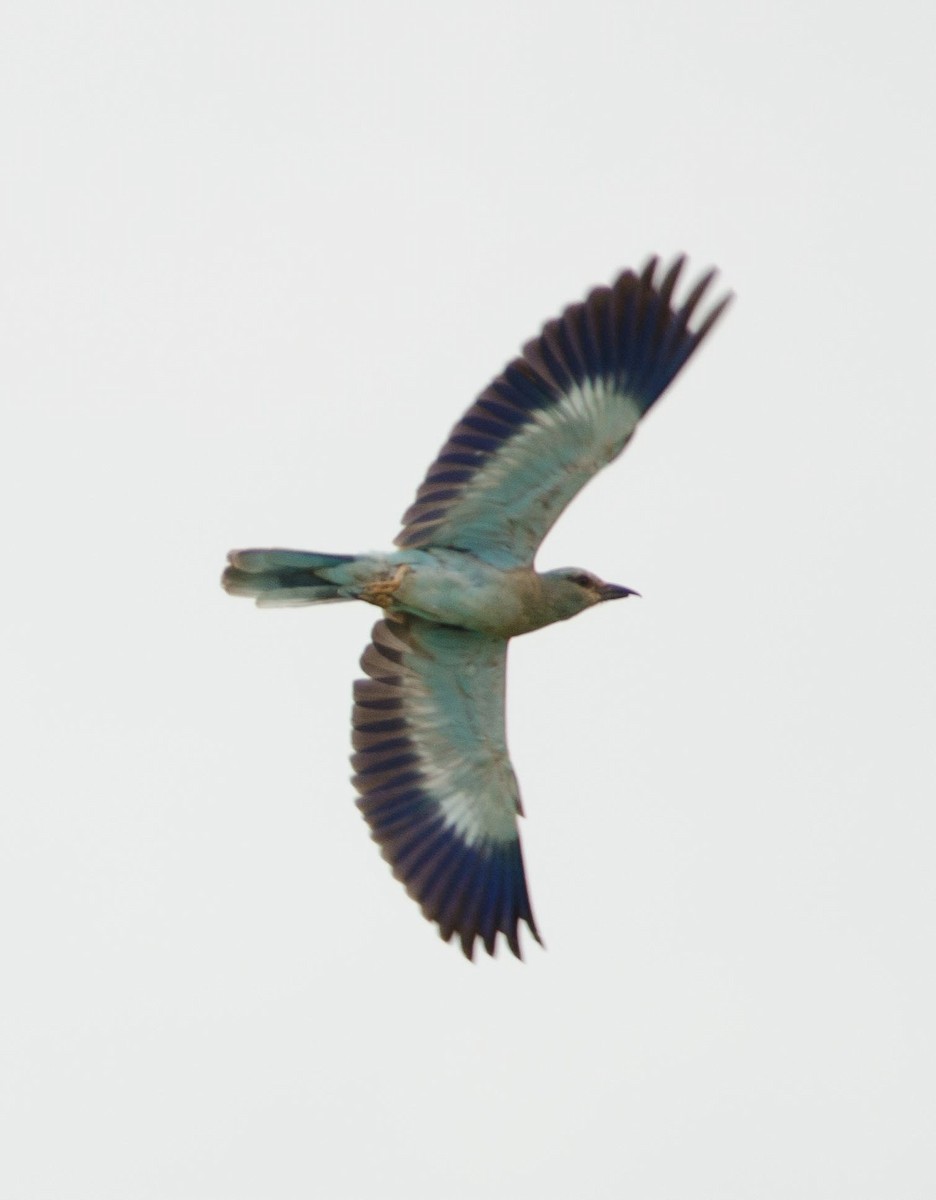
[[352, 616, 539, 958]]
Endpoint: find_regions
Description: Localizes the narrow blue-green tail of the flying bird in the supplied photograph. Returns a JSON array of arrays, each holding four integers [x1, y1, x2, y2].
[[221, 550, 356, 608]]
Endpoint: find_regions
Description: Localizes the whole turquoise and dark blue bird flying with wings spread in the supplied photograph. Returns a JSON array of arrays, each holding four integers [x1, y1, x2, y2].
[[222, 257, 731, 959]]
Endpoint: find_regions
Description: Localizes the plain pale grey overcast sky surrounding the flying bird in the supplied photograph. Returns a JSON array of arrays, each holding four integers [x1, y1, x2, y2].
[[0, 0, 936, 1200]]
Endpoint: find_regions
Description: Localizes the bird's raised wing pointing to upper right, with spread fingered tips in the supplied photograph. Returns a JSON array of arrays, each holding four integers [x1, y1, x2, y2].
[[396, 257, 731, 568]]
